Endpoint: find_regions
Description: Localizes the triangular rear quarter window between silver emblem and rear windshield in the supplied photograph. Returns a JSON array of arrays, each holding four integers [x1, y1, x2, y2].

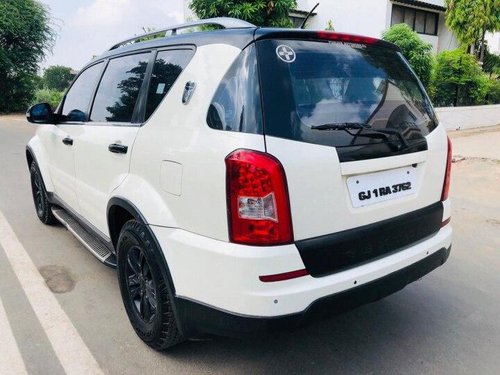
[[207, 45, 262, 134]]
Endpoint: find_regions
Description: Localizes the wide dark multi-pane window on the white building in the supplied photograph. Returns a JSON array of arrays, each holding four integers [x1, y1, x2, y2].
[[391, 5, 439, 35]]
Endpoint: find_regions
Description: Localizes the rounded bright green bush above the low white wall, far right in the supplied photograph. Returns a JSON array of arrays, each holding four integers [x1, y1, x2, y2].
[[433, 49, 490, 106]]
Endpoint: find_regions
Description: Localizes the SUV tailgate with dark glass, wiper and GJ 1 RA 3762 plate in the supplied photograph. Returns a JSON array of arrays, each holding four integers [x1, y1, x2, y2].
[[257, 39, 447, 242]]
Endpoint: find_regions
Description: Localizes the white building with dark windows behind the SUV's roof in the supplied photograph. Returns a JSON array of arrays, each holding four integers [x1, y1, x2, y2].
[[292, 0, 458, 53]]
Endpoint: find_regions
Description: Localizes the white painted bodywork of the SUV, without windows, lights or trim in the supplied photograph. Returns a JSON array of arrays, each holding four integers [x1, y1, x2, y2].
[[30, 40, 452, 316]]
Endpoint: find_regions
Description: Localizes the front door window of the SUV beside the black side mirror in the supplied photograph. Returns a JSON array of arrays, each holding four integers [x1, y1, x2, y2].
[[61, 63, 102, 122]]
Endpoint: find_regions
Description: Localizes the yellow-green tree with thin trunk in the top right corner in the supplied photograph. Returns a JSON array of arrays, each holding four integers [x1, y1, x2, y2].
[[445, 0, 500, 61]]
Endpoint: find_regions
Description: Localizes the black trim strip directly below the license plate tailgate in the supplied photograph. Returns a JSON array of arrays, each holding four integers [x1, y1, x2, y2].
[[295, 202, 443, 277]]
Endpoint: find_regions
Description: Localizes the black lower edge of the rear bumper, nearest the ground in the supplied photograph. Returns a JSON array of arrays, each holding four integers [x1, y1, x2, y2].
[[175, 246, 451, 337]]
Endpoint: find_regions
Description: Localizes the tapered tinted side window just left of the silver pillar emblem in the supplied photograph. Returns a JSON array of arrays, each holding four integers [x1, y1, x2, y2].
[[146, 49, 194, 120]]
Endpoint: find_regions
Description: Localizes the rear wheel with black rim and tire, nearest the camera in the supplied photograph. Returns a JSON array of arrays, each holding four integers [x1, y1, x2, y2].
[[117, 220, 184, 350]]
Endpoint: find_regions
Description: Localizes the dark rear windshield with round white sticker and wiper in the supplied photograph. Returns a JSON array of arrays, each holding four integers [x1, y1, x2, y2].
[[257, 40, 437, 161]]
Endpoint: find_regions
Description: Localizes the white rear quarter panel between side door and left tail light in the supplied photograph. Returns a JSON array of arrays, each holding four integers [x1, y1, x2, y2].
[[112, 44, 265, 241]]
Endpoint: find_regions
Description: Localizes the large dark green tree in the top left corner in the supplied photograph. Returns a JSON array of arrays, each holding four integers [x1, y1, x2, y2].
[[0, 0, 54, 112]]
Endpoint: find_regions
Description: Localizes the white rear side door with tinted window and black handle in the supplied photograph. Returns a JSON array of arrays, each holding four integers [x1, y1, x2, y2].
[[74, 52, 152, 234]]
